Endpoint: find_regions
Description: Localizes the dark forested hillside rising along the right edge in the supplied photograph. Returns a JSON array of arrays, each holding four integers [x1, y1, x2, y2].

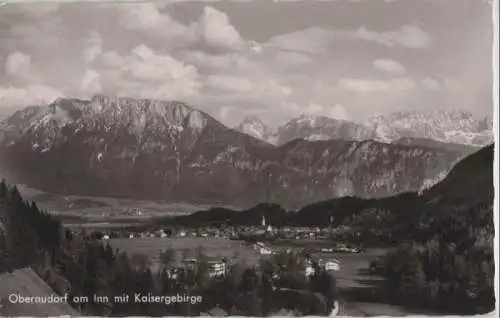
[[374, 146, 495, 314]]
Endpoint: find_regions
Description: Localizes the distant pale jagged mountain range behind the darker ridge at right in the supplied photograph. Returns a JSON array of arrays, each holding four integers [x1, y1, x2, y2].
[[236, 110, 493, 150]]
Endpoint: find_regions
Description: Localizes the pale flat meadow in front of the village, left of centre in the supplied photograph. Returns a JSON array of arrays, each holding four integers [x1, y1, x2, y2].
[[109, 237, 260, 264]]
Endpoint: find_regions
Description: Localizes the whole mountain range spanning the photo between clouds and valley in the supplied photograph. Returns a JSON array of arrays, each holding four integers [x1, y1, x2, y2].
[[0, 95, 490, 207]]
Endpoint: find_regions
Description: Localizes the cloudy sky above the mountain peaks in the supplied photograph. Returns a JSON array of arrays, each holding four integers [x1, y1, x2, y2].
[[0, 0, 493, 126]]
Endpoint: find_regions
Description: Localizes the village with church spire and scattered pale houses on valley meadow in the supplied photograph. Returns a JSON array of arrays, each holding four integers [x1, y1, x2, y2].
[[84, 216, 361, 279]]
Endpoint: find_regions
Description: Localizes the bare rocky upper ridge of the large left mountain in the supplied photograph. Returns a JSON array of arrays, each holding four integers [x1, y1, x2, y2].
[[0, 95, 216, 144]]
